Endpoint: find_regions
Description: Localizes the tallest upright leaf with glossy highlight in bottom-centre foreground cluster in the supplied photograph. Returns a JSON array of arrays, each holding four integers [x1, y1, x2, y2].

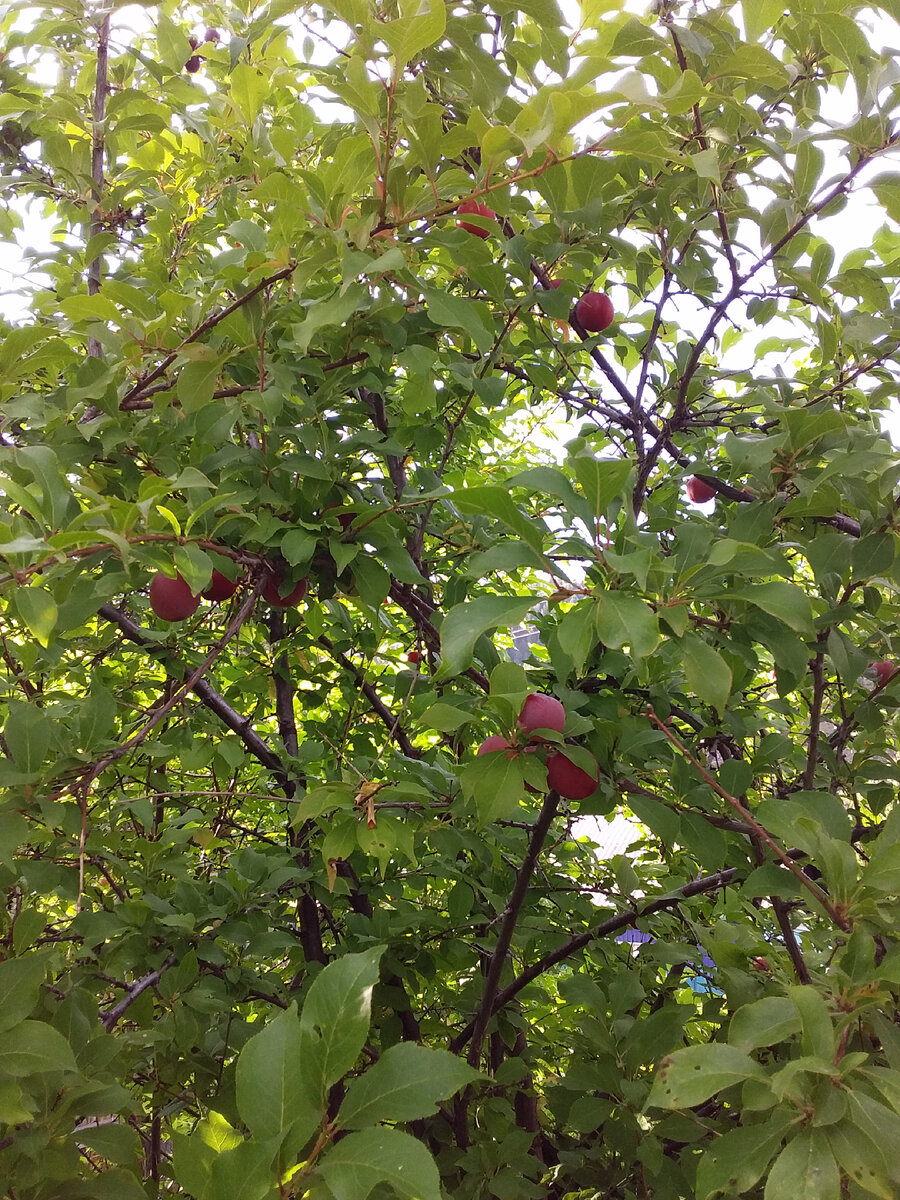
[[300, 946, 384, 1093]]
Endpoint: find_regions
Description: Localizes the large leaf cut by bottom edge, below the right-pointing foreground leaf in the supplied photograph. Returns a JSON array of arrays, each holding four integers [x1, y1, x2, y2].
[[318, 1128, 440, 1200]]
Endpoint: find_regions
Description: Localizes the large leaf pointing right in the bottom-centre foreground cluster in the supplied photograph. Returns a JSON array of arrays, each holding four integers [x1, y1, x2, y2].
[[337, 1042, 478, 1129]]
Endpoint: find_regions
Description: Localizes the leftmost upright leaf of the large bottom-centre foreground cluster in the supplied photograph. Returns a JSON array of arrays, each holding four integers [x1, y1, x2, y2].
[[235, 1004, 322, 1148]]
